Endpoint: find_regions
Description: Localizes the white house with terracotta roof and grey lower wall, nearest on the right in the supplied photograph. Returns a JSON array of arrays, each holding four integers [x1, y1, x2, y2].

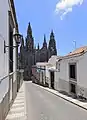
[[55, 46, 87, 98]]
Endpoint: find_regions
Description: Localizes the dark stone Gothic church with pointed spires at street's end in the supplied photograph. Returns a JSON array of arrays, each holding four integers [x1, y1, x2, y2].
[[19, 23, 57, 80]]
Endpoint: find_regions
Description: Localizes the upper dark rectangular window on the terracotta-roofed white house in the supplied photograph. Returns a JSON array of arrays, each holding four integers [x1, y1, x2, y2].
[[69, 64, 76, 79]]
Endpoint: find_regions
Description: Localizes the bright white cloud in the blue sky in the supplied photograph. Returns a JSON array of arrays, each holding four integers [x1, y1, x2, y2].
[[55, 0, 84, 20]]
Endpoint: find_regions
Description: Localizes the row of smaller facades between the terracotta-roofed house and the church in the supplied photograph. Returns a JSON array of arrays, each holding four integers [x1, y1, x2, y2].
[[32, 56, 58, 89]]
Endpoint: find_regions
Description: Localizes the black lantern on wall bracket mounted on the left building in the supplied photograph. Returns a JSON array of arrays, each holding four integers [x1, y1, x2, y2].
[[4, 33, 23, 53]]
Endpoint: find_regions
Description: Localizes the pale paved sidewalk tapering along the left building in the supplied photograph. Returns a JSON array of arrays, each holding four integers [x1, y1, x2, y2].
[[6, 83, 27, 120]]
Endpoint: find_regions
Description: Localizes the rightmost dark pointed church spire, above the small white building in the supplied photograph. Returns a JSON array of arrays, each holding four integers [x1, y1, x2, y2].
[[48, 30, 57, 59]]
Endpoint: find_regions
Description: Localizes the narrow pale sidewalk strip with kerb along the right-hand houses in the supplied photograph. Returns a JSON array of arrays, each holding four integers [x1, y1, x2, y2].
[[40, 86, 87, 110]]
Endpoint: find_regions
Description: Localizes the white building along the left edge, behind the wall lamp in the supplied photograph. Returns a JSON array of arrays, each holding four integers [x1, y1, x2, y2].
[[0, 0, 18, 120]]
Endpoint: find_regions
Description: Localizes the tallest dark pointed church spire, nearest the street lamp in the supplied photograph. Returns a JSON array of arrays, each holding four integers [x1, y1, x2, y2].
[[26, 22, 34, 52]]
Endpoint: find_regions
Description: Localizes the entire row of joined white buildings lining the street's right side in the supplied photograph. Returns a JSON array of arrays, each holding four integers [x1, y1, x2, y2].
[[32, 46, 87, 101]]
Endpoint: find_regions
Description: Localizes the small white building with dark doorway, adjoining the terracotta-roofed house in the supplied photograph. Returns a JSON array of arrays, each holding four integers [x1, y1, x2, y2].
[[36, 56, 58, 88]]
